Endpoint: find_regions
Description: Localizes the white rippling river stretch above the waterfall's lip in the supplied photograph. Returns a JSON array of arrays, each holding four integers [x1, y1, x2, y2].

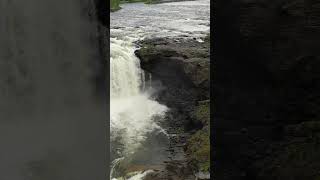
[[110, 0, 210, 38]]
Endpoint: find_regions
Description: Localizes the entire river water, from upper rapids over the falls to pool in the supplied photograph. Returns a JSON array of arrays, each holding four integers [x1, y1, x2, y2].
[[110, 0, 210, 180]]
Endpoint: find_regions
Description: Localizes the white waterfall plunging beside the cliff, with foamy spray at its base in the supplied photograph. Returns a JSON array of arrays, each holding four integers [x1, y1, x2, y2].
[[110, 38, 167, 178]]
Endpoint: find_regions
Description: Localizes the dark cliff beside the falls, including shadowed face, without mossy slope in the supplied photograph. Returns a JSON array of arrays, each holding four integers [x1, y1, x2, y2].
[[135, 38, 210, 136]]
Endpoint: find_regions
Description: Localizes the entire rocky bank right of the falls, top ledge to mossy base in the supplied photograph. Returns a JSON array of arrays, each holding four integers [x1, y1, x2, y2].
[[135, 37, 210, 180]]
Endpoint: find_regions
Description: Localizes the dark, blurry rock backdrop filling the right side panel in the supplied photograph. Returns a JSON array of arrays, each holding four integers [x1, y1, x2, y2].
[[212, 0, 320, 180]]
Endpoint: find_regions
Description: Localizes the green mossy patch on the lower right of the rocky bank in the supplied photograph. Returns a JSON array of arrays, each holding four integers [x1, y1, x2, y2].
[[187, 101, 210, 172]]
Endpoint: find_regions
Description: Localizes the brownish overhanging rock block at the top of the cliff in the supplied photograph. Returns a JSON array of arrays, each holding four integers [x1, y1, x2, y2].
[[136, 38, 210, 101]]
